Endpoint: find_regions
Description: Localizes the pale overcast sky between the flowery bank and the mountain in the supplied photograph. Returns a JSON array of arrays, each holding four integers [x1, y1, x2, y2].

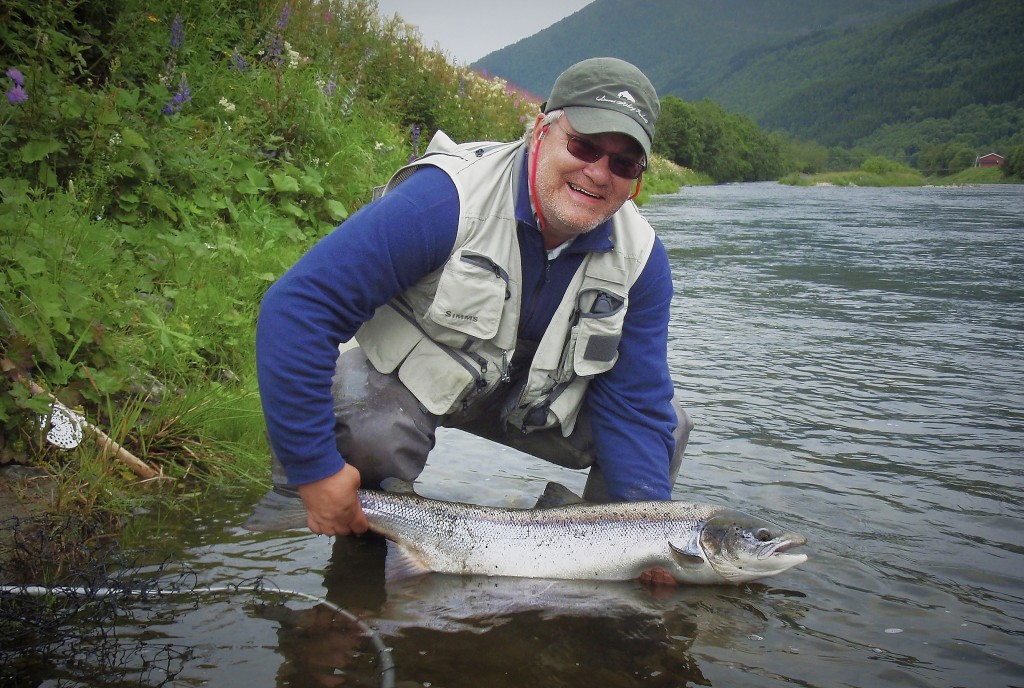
[[377, 0, 593, 65]]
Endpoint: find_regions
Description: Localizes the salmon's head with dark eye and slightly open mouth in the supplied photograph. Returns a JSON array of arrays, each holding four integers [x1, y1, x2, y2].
[[699, 509, 807, 584]]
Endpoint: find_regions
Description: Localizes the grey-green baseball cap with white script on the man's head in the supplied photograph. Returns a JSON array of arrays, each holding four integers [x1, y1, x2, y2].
[[542, 57, 662, 158]]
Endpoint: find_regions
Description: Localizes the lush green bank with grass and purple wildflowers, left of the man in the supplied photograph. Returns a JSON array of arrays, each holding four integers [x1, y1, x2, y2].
[[0, 0, 538, 489]]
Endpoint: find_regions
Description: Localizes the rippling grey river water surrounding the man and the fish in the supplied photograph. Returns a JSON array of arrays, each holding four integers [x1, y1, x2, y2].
[[44, 183, 1024, 688]]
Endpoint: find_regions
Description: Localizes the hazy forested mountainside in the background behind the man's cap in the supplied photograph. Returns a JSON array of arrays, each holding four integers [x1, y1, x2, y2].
[[477, 0, 1024, 160]]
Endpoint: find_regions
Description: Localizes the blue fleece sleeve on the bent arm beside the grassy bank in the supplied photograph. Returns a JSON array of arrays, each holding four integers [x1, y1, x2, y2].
[[256, 167, 459, 484]]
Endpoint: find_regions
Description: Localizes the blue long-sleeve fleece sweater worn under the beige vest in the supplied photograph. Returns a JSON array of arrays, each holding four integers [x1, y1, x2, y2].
[[256, 147, 676, 501]]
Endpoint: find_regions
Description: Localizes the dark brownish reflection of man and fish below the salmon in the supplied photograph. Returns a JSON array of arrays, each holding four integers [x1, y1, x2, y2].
[[239, 538, 806, 688]]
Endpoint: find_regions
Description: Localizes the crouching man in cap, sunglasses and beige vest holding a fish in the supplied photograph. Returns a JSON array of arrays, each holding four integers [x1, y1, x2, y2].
[[256, 57, 691, 565]]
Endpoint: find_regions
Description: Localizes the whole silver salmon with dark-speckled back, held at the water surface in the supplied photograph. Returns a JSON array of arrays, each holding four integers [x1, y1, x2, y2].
[[245, 489, 807, 585]]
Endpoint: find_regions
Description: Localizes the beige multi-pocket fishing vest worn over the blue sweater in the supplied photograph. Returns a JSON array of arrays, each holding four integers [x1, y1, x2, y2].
[[355, 132, 654, 436]]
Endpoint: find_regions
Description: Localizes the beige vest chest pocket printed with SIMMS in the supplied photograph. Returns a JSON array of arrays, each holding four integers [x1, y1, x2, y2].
[[424, 251, 509, 348]]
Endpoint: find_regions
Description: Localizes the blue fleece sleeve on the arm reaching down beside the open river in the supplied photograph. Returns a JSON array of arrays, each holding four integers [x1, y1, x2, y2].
[[587, 241, 676, 501]]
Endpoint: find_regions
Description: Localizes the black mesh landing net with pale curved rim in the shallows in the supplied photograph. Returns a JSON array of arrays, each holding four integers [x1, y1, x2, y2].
[[0, 517, 393, 688]]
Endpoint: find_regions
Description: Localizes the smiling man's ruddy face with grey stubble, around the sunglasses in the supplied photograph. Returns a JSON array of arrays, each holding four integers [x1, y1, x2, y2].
[[531, 115, 643, 248]]
